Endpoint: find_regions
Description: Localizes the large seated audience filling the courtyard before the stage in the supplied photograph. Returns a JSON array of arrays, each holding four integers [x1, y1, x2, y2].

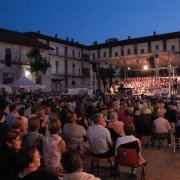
[[0, 92, 180, 180]]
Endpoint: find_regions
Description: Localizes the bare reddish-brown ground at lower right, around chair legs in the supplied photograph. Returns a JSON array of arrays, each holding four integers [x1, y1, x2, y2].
[[84, 137, 180, 180]]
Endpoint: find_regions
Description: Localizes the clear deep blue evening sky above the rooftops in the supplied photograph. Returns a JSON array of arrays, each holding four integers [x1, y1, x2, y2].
[[0, 0, 180, 45]]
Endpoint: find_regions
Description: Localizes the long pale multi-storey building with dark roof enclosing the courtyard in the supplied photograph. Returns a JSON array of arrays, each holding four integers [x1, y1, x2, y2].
[[0, 29, 180, 92]]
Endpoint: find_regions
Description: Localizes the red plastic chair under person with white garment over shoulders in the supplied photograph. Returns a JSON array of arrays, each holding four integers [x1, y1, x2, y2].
[[115, 147, 146, 179]]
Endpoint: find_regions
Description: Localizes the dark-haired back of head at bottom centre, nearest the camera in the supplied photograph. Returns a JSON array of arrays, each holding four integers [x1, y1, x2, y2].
[[61, 149, 83, 173]]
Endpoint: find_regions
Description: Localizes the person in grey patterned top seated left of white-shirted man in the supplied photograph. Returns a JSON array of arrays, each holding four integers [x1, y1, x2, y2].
[[62, 113, 86, 150]]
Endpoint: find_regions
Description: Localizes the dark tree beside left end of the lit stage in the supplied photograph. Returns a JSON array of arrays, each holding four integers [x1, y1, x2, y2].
[[97, 67, 115, 89]]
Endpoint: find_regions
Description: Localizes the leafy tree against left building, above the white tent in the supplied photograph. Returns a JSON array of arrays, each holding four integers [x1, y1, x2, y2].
[[27, 48, 49, 78]]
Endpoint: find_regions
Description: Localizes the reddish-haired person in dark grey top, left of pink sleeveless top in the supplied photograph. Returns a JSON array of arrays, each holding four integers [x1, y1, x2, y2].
[[23, 117, 45, 156]]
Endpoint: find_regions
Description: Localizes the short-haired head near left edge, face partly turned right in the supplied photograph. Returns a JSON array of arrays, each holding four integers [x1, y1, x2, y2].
[[5, 130, 22, 151]]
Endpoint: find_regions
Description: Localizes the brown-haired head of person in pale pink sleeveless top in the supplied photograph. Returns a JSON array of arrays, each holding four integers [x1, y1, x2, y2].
[[48, 118, 61, 134]]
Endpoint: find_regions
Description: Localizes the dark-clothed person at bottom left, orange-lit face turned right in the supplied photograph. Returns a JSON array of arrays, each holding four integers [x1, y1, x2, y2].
[[17, 147, 59, 180]]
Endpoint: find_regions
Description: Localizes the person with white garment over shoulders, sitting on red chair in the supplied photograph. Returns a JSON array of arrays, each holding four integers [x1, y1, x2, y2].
[[115, 124, 145, 176]]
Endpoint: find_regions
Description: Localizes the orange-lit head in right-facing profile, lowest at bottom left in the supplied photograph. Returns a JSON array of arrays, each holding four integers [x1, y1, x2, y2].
[[21, 147, 41, 171]]
